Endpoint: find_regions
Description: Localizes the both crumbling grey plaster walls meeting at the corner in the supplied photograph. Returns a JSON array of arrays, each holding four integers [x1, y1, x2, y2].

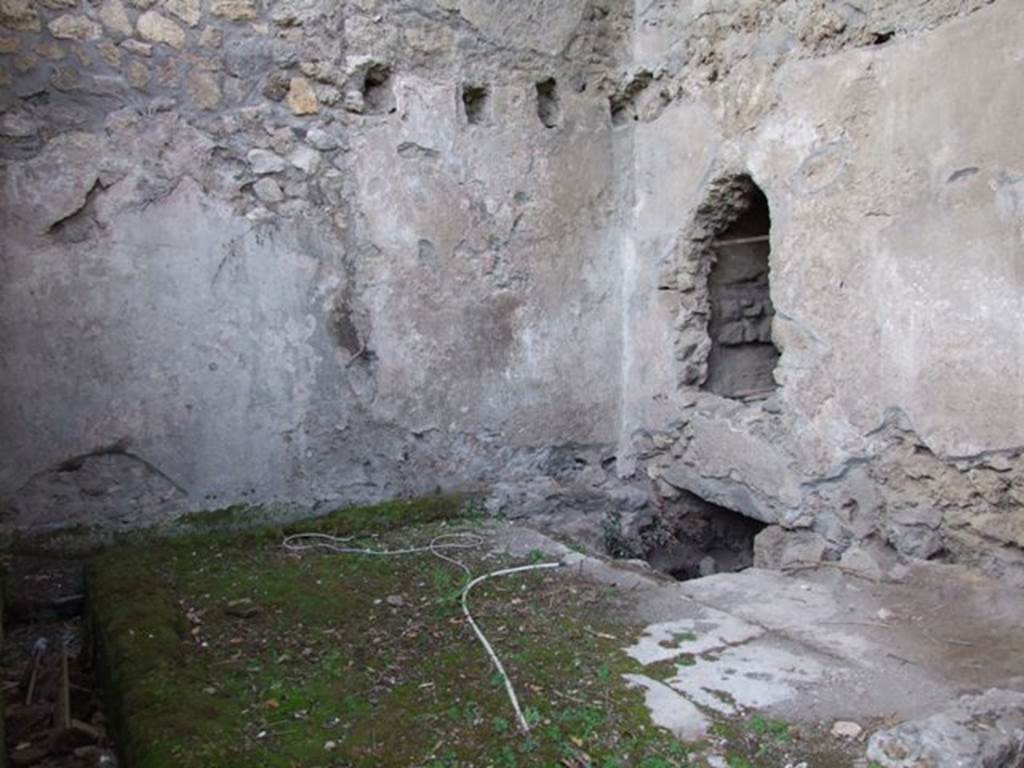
[[0, 0, 1024, 573]]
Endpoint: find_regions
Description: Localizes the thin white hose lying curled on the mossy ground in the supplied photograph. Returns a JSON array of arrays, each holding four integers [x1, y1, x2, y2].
[[282, 531, 561, 735]]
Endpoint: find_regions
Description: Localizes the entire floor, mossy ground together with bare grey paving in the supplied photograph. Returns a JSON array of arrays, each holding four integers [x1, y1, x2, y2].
[[8, 499, 1024, 768]]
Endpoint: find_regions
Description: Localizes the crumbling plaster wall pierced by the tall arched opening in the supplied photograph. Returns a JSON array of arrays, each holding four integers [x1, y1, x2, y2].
[[623, 2, 1024, 574]]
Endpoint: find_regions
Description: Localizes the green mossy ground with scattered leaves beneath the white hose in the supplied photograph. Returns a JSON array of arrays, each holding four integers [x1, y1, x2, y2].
[[89, 501, 856, 768]]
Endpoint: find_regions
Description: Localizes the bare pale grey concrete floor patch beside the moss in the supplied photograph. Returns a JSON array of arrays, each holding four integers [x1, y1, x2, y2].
[[496, 524, 1024, 768]]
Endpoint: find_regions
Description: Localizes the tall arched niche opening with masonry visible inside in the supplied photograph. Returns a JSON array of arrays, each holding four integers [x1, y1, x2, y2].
[[702, 176, 779, 400]]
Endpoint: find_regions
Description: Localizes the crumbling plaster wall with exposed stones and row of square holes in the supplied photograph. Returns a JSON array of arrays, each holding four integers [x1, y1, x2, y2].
[[0, 0, 631, 527]]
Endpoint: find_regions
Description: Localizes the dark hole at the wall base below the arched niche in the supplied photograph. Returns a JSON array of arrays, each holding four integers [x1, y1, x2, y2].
[[643, 490, 765, 581]]
